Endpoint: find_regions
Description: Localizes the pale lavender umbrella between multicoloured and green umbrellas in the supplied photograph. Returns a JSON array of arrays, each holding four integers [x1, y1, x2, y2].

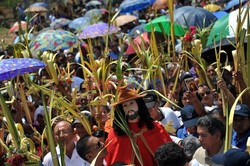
[[79, 23, 120, 39]]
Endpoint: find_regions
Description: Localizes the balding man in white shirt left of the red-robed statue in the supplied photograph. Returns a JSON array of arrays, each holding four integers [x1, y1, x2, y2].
[[43, 120, 90, 166]]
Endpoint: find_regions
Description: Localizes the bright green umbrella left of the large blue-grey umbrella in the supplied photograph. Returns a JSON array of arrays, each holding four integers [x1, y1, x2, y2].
[[145, 15, 185, 36]]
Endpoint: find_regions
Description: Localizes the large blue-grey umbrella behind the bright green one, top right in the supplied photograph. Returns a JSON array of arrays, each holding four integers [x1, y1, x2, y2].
[[167, 6, 217, 28]]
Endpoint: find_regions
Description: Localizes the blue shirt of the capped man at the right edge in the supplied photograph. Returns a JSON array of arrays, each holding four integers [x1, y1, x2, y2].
[[232, 130, 250, 151]]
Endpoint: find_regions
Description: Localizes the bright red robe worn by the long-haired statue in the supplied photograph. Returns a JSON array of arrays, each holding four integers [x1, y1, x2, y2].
[[105, 122, 172, 166]]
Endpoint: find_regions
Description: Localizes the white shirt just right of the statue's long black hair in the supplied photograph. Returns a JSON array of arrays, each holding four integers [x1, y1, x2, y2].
[[159, 107, 181, 129]]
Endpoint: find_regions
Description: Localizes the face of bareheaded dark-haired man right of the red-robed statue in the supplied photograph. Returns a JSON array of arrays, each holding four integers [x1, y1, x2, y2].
[[197, 126, 220, 150]]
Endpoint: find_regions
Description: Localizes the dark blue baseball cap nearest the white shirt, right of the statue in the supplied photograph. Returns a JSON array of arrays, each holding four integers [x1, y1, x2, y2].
[[181, 105, 198, 128]]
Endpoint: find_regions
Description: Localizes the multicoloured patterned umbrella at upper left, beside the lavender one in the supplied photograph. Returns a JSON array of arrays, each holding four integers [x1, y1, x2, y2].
[[29, 29, 79, 52]]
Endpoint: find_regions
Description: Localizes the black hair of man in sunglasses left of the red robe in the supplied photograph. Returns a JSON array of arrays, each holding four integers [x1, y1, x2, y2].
[[76, 134, 91, 161]]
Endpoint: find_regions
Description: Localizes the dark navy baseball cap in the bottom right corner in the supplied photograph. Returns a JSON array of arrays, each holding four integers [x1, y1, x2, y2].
[[212, 148, 250, 166]]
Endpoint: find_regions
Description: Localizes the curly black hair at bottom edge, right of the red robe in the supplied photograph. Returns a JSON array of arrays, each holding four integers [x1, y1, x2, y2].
[[155, 142, 187, 166]]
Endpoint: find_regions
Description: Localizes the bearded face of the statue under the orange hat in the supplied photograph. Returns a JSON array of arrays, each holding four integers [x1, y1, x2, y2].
[[122, 100, 139, 122]]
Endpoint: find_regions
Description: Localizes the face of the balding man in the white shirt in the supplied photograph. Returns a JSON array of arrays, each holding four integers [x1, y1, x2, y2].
[[53, 121, 74, 145]]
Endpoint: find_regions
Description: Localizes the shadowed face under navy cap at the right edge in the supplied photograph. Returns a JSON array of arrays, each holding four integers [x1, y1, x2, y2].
[[233, 115, 250, 135]]
